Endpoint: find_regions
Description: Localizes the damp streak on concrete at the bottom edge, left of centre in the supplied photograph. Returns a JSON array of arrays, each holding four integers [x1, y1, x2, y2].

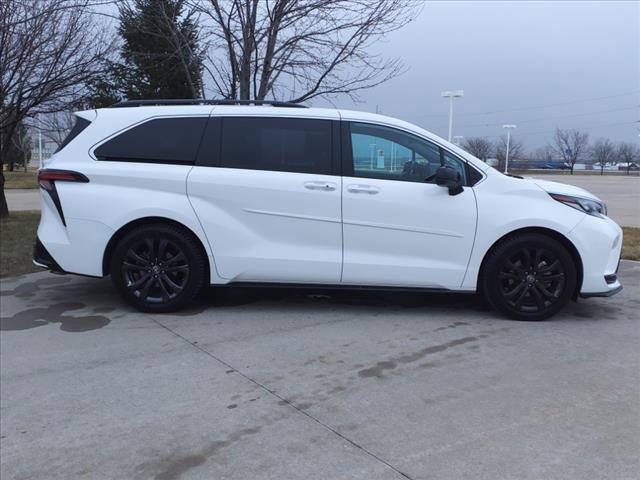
[[136, 427, 261, 480]]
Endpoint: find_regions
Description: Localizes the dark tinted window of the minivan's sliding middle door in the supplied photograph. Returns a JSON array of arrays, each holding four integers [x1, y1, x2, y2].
[[220, 118, 331, 174]]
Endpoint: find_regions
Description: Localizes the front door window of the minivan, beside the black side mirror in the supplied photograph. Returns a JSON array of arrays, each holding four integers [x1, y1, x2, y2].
[[350, 123, 466, 183]]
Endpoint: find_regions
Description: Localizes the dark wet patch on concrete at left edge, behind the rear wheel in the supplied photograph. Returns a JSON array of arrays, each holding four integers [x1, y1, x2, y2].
[[0, 302, 111, 333]]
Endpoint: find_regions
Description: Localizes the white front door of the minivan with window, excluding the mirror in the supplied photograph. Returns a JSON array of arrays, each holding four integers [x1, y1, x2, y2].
[[342, 122, 477, 288]]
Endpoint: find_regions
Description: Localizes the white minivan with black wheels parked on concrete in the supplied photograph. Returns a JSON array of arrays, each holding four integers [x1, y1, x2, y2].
[[34, 100, 622, 320]]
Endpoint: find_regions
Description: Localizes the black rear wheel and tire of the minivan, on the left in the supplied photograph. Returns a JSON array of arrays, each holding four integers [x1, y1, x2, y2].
[[109, 224, 208, 313]]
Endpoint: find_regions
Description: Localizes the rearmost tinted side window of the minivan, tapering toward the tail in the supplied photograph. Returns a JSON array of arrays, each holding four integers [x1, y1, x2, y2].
[[94, 117, 207, 164]]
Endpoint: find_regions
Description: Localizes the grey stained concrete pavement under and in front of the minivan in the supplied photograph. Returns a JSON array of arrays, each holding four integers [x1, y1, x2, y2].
[[0, 261, 640, 480]]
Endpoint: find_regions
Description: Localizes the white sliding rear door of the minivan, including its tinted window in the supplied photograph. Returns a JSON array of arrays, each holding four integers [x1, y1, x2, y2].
[[187, 113, 342, 283]]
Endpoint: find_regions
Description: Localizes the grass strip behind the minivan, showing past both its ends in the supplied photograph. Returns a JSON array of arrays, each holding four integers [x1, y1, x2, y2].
[[0, 212, 640, 278]]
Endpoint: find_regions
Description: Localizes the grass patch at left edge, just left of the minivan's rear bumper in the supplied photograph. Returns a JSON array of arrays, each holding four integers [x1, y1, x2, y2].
[[0, 212, 41, 278]]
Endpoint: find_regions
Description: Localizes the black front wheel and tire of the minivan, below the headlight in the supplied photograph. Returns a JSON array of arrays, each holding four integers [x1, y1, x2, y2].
[[479, 233, 577, 321]]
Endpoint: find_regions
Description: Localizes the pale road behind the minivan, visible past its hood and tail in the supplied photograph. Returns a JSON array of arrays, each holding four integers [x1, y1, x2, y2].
[[6, 175, 640, 227]]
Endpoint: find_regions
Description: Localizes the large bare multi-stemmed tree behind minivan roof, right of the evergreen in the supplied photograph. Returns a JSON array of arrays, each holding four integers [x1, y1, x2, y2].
[[191, 0, 422, 102]]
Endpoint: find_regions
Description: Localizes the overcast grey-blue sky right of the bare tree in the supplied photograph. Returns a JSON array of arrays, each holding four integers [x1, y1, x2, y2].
[[314, 1, 640, 150]]
